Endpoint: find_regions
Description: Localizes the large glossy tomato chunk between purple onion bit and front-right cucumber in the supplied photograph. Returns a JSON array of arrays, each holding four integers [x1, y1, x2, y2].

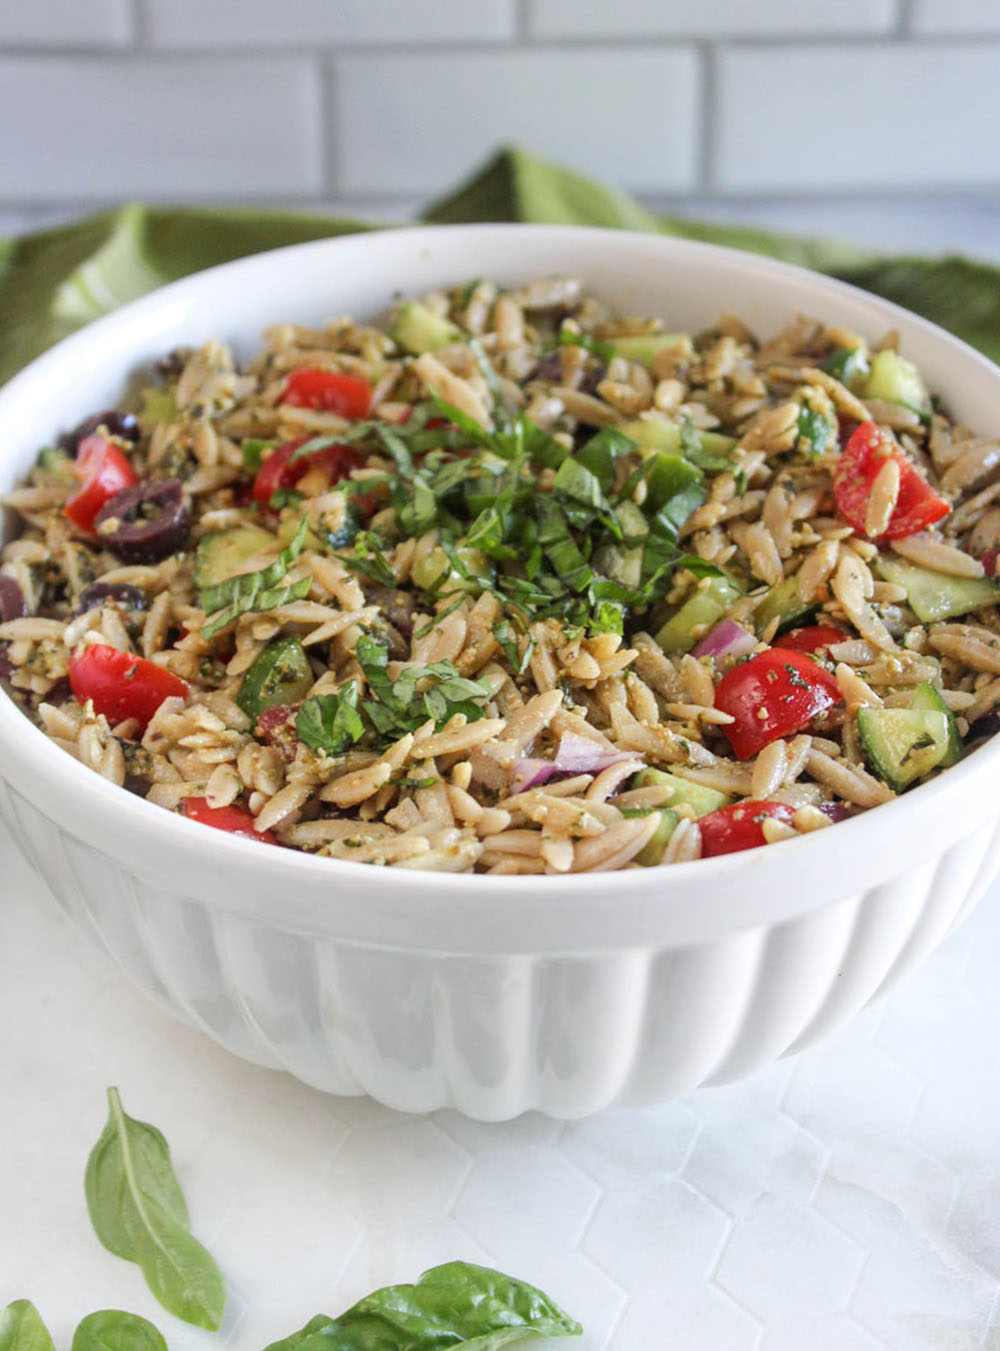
[[715, 647, 841, 759]]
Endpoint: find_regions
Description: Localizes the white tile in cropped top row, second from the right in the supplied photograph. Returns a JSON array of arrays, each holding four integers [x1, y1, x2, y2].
[[527, 0, 891, 38]]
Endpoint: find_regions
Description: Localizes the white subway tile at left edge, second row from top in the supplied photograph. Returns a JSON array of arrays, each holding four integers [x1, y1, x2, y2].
[[0, 57, 323, 201]]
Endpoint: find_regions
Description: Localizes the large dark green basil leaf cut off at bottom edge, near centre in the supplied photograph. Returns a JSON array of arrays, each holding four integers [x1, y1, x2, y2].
[[266, 1262, 582, 1351]]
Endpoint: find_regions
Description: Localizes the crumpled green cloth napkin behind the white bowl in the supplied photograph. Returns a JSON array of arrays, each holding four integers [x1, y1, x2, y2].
[[0, 149, 1000, 382]]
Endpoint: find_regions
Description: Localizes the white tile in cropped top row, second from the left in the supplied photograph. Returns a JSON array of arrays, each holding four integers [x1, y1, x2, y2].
[[146, 0, 515, 47]]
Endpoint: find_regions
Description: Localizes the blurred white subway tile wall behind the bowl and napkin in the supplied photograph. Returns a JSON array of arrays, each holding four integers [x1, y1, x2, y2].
[[0, 0, 1000, 257]]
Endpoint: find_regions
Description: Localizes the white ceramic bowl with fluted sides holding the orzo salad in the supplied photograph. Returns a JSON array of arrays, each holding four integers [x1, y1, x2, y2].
[[0, 226, 1000, 1120]]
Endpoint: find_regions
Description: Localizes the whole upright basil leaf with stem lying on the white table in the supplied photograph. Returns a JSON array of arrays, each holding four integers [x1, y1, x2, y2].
[[84, 1088, 226, 1329]]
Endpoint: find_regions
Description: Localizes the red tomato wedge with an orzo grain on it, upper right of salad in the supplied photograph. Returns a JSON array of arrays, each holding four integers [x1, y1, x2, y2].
[[834, 423, 951, 539]]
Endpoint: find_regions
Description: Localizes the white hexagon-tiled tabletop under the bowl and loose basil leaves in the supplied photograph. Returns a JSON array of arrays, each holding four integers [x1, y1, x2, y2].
[[0, 810, 1000, 1351]]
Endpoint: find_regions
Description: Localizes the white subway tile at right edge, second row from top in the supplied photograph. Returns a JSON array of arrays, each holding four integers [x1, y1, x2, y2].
[[715, 43, 1000, 192]]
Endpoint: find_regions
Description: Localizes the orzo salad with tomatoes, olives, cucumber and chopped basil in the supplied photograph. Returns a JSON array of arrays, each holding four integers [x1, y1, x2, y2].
[[0, 278, 1000, 874]]
